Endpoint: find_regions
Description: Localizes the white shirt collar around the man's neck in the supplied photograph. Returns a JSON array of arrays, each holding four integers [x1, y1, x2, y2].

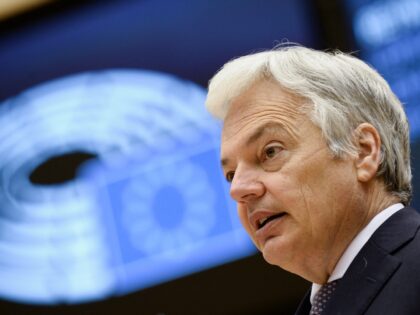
[[311, 203, 404, 304]]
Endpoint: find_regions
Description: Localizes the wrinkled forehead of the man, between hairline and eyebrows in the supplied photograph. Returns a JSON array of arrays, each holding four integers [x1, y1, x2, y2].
[[222, 80, 308, 146]]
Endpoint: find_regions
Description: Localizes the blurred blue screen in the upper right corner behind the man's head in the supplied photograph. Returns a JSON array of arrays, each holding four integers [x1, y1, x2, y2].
[[346, 0, 420, 139]]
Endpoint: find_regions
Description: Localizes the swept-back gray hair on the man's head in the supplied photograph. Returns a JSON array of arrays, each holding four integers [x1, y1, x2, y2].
[[206, 46, 412, 205]]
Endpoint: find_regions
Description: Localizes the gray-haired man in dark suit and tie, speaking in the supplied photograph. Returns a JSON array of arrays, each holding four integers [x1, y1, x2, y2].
[[206, 46, 420, 315]]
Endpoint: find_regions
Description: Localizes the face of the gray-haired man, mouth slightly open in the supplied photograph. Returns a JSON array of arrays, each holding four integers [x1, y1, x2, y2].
[[221, 80, 364, 282]]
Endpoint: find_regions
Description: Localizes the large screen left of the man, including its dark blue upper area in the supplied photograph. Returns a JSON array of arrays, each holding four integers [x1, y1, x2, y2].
[[0, 0, 319, 304]]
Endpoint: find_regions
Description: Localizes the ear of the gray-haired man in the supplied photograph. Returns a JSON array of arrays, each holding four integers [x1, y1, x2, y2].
[[355, 123, 381, 182]]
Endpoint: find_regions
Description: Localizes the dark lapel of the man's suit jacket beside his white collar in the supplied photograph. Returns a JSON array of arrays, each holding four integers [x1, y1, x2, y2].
[[324, 208, 420, 315]]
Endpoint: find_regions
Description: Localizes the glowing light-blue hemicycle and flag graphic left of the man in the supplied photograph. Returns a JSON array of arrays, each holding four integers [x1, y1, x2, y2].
[[0, 70, 255, 303]]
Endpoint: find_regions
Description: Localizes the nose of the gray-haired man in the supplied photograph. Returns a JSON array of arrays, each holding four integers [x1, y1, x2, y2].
[[230, 167, 265, 203]]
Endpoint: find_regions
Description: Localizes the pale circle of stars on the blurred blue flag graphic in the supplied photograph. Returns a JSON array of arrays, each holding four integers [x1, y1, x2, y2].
[[122, 161, 216, 258]]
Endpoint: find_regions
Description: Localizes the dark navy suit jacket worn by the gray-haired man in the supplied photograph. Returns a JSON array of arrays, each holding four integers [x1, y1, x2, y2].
[[295, 208, 420, 315]]
